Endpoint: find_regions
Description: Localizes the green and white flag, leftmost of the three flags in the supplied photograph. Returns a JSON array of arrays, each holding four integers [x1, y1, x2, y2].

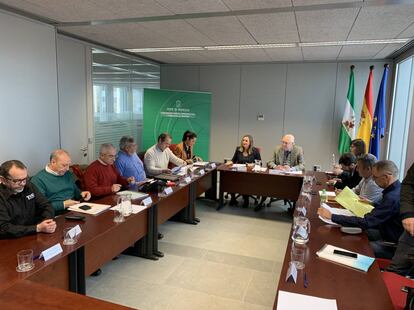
[[338, 65, 355, 154]]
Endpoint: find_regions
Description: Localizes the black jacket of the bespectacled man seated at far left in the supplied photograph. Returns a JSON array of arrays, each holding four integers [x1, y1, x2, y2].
[[0, 183, 54, 239]]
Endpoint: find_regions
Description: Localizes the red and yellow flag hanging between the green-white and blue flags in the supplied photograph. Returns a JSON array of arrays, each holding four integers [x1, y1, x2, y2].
[[357, 66, 374, 149]]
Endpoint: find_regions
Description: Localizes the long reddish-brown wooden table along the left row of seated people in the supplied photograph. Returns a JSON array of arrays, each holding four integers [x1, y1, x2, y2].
[[0, 165, 216, 302]]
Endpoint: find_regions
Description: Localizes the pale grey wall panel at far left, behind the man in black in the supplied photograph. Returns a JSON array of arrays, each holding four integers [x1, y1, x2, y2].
[[0, 12, 59, 173]]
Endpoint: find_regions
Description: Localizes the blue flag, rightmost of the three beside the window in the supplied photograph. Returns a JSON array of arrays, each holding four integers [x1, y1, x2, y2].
[[369, 64, 388, 159]]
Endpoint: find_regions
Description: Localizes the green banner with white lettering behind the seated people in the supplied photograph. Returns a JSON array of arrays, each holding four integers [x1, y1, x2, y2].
[[142, 89, 211, 160]]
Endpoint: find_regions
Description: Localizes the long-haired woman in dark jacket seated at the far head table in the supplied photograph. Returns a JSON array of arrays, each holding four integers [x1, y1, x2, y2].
[[226, 135, 262, 208]]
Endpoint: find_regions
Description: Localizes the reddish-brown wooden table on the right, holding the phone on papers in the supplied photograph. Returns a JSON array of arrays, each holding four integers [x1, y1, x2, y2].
[[274, 172, 393, 310]]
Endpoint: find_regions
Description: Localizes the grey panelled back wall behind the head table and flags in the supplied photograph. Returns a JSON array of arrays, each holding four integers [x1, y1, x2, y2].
[[161, 61, 392, 169]]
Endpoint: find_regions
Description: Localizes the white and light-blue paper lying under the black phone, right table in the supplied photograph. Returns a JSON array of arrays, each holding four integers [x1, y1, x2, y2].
[[316, 244, 375, 272]]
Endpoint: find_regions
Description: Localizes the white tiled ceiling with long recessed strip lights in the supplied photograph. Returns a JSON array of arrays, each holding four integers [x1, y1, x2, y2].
[[0, 0, 414, 63]]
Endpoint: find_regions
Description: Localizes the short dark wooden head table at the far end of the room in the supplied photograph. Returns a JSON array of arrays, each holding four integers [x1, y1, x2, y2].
[[217, 164, 303, 210]]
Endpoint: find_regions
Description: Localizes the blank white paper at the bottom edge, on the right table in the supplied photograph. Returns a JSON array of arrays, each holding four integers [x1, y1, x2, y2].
[[277, 291, 338, 310]]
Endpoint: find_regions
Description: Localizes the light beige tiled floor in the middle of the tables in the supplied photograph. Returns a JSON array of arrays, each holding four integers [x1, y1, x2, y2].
[[87, 200, 291, 310]]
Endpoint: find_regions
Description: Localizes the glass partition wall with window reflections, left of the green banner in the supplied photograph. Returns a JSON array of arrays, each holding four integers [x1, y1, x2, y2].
[[92, 49, 160, 158]]
